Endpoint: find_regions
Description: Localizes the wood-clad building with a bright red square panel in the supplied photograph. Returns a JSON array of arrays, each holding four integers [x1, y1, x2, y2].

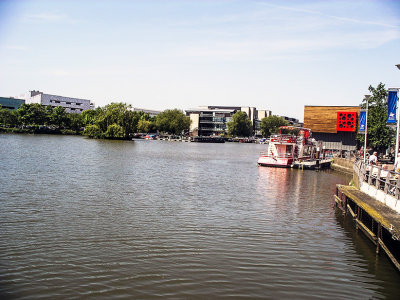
[[304, 105, 360, 150]]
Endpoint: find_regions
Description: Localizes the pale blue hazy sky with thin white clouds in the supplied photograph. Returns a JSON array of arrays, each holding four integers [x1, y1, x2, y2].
[[0, 0, 400, 120]]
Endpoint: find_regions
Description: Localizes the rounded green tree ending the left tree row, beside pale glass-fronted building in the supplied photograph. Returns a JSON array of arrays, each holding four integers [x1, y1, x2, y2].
[[155, 109, 190, 135]]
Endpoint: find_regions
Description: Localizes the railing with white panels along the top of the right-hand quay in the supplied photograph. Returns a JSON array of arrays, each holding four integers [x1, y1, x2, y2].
[[353, 159, 400, 200]]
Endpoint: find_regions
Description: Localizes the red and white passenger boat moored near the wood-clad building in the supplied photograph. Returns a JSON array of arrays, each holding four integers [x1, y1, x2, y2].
[[258, 126, 316, 168]]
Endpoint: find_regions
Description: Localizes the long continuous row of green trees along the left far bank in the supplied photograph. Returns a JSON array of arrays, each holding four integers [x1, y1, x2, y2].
[[0, 103, 190, 139]]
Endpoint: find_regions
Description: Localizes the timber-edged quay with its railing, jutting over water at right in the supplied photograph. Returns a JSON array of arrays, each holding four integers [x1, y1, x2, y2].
[[334, 161, 400, 271]]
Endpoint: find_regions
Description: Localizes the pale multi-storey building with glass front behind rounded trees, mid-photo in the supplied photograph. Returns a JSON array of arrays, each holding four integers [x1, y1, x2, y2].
[[186, 106, 271, 136]]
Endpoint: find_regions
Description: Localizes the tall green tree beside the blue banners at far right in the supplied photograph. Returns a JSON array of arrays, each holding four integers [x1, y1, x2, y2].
[[358, 82, 395, 152]]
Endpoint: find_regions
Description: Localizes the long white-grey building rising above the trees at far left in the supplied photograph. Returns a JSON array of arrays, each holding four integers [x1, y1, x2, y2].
[[22, 91, 94, 113]]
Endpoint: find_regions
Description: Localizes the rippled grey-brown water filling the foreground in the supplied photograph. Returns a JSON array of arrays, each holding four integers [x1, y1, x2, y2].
[[0, 134, 400, 299]]
